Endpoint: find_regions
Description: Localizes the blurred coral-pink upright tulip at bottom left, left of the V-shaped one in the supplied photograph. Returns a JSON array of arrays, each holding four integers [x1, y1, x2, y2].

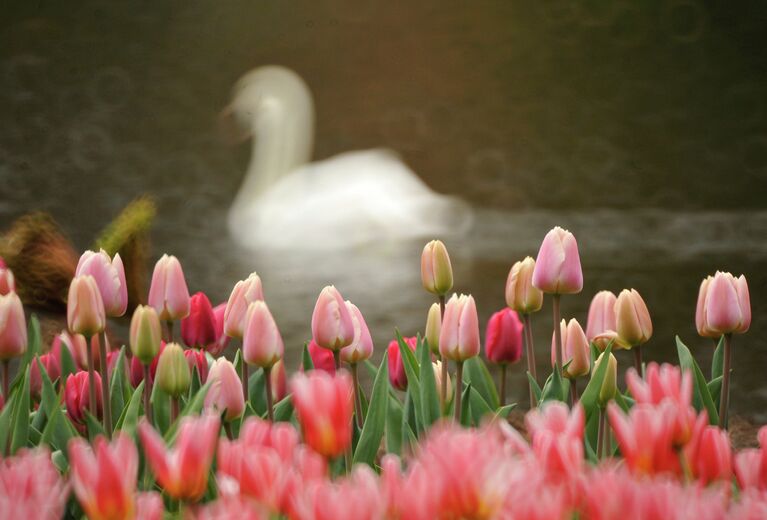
[[69, 432, 138, 520]]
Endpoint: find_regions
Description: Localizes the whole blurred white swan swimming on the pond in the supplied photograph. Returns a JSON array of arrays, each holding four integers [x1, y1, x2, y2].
[[227, 66, 471, 249]]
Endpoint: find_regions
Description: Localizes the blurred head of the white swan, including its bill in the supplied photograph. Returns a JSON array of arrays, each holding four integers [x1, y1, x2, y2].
[[222, 65, 314, 140]]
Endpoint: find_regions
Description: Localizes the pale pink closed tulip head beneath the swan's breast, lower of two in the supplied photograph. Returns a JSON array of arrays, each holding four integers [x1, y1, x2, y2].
[[242, 300, 285, 368]]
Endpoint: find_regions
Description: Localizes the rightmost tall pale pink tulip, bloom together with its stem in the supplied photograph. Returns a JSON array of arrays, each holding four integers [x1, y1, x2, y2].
[[695, 271, 751, 428]]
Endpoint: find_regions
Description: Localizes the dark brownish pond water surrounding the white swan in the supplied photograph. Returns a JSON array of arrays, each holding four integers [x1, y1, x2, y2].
[[0, 0, 767, 421]]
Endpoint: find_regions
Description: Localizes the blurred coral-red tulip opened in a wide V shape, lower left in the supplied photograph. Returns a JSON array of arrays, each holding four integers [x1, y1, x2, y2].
[[138, 412, 221, 502]]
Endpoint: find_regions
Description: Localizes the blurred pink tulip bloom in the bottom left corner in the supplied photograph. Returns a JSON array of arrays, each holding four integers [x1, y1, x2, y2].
[[0, 447, 69, 520]]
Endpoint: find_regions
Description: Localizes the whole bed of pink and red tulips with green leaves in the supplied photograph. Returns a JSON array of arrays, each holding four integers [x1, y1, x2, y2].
[[0, 224, 756, 519]]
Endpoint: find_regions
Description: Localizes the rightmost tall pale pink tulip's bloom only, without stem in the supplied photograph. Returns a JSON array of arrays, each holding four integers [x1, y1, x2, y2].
[[695, 271, 751, 338]]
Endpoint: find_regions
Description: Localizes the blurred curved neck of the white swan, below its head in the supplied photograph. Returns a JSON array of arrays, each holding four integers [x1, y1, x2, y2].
[[232, 99, 314, 213]]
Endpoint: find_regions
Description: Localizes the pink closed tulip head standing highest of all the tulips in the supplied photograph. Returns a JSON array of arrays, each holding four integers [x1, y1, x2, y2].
[[533, 226, 583, 294]]
